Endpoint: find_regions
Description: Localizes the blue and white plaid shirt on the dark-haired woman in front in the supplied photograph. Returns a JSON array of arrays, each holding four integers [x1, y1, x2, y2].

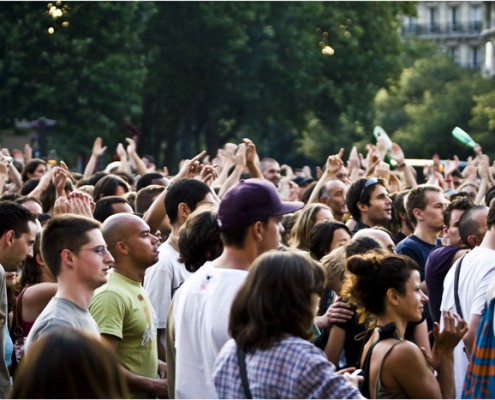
[[213, 336, 362, 399]]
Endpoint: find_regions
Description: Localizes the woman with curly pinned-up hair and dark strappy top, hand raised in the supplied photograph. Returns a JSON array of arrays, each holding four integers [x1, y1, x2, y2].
[[343, 253, 467, 398]]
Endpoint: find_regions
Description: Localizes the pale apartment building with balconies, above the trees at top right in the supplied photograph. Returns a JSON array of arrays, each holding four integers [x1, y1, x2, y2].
[[402, 1, 484, 72]]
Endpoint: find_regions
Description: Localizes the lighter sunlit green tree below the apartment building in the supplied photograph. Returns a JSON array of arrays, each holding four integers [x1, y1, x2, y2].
[[376, 53, 495, 158]]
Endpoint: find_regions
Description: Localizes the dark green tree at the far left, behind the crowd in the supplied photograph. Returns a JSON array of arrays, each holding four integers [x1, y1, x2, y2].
[[0, 2, 153, 165]]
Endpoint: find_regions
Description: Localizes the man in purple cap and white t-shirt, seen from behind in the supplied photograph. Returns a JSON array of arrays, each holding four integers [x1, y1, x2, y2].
[[169, 179, 303, 398]]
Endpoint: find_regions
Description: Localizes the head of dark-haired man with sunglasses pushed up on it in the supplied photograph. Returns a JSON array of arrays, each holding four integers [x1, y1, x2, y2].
[[346, 178, 392, 235]]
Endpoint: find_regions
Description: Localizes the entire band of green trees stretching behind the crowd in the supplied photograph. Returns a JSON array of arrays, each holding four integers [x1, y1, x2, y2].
[[6, 2, 495, 172]]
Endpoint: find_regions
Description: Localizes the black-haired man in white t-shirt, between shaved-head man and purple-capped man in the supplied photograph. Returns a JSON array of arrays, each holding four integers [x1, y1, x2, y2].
[[143, 178, 214, 361]]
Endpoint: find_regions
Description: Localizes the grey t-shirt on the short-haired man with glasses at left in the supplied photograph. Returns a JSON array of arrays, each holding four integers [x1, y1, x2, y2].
[[25, 297, 100, 351]]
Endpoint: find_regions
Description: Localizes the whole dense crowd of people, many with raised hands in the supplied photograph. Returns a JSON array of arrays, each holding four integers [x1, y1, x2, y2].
[[0, 133, 495, 398]]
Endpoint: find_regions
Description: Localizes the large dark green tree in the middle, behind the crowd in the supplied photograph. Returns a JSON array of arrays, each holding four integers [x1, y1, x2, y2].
[[143, 2, 410, 168]]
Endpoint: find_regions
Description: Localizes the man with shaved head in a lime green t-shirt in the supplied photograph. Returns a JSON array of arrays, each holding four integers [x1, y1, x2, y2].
[[89, 213, 167, 398]]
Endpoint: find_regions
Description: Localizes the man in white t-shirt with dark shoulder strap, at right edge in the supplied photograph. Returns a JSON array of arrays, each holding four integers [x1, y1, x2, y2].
[[440, 203, 495, 398]]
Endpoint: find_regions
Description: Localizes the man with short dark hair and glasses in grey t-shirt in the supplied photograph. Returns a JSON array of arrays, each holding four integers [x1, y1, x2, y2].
[[25, 214, 114, 352]]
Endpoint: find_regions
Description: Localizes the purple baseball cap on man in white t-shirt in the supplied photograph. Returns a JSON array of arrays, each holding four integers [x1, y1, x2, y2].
[[218, 178, 304, 229]]
